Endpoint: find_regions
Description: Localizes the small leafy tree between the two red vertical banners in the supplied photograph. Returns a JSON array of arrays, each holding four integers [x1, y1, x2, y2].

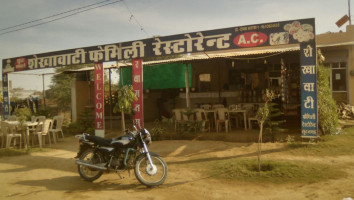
[[113, 85, 138, 132]]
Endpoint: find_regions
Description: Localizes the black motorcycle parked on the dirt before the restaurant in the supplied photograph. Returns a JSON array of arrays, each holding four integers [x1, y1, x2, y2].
[[75, 126, 167, 187]]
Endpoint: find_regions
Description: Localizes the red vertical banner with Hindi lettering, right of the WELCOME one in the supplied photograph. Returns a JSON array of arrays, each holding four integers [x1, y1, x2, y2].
[[132, 59, 144, 128]]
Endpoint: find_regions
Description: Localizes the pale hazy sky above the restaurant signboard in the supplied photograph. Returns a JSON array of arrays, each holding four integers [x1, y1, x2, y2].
[[0, 0, 354, 91]]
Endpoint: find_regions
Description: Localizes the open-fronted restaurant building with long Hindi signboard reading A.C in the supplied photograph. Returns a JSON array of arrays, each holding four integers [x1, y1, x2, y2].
[[3, 19, 354, 137]]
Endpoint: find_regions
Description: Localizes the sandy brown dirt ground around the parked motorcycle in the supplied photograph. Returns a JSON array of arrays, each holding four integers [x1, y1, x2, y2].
[[0, 136, 354, 200]]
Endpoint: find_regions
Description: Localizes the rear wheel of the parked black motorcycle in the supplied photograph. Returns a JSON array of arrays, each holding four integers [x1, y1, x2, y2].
[[77, 149, 103, 182]]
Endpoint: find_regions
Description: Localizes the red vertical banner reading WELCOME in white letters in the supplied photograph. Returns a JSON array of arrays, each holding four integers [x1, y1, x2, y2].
[[94, 63, 104, 137]]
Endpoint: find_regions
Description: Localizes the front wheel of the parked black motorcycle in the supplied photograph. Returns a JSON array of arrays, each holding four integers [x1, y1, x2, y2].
[[134, 155, 167, 187]]
